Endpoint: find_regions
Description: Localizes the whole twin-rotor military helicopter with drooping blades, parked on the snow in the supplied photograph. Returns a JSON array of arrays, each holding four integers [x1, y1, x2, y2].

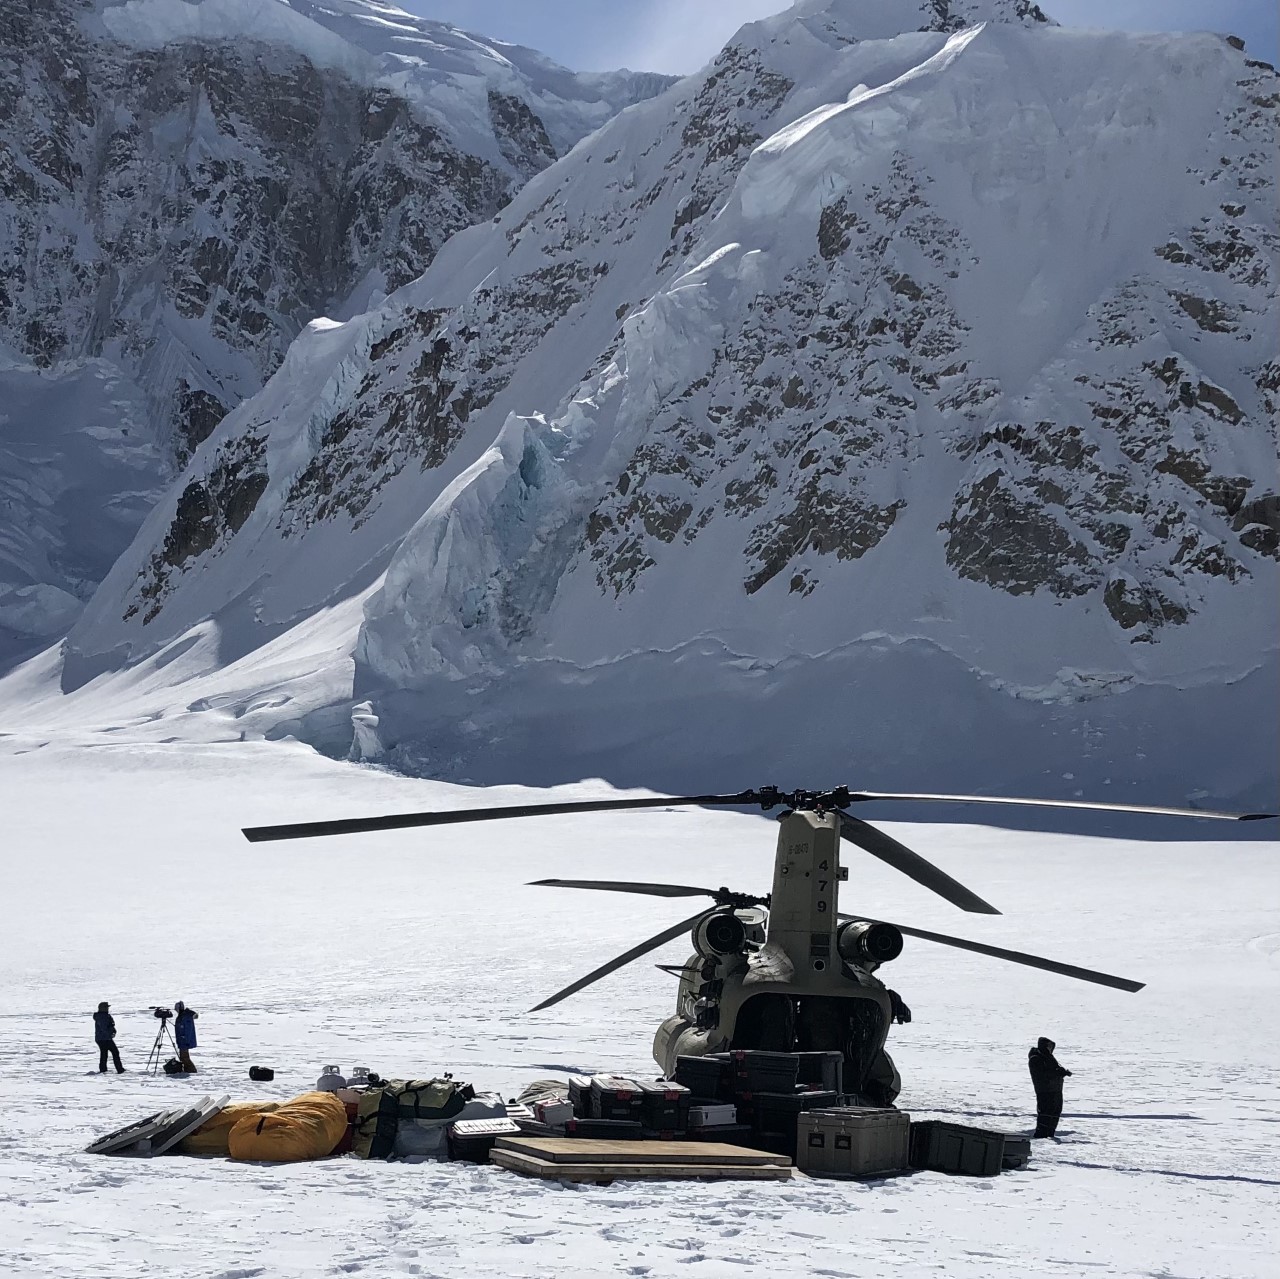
[[243, 786, 1275, 1105]]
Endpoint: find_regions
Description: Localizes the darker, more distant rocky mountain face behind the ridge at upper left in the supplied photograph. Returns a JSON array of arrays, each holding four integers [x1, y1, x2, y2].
[[0, 0, 668, 662]]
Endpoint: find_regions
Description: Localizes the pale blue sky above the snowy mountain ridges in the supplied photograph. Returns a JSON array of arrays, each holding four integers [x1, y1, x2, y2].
[[399, 0, 1280, 74]]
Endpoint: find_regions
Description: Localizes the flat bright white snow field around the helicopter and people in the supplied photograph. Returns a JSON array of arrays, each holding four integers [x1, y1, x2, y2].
[[0, 742, 1280, 1279]]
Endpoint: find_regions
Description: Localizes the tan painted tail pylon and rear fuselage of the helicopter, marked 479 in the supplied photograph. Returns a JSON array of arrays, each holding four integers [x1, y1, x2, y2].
[[653, 812, 892, 1075]]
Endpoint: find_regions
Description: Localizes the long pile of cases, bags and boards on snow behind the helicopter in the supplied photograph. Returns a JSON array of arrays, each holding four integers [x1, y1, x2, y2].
[[88, 1050, 1030, 1182]]
